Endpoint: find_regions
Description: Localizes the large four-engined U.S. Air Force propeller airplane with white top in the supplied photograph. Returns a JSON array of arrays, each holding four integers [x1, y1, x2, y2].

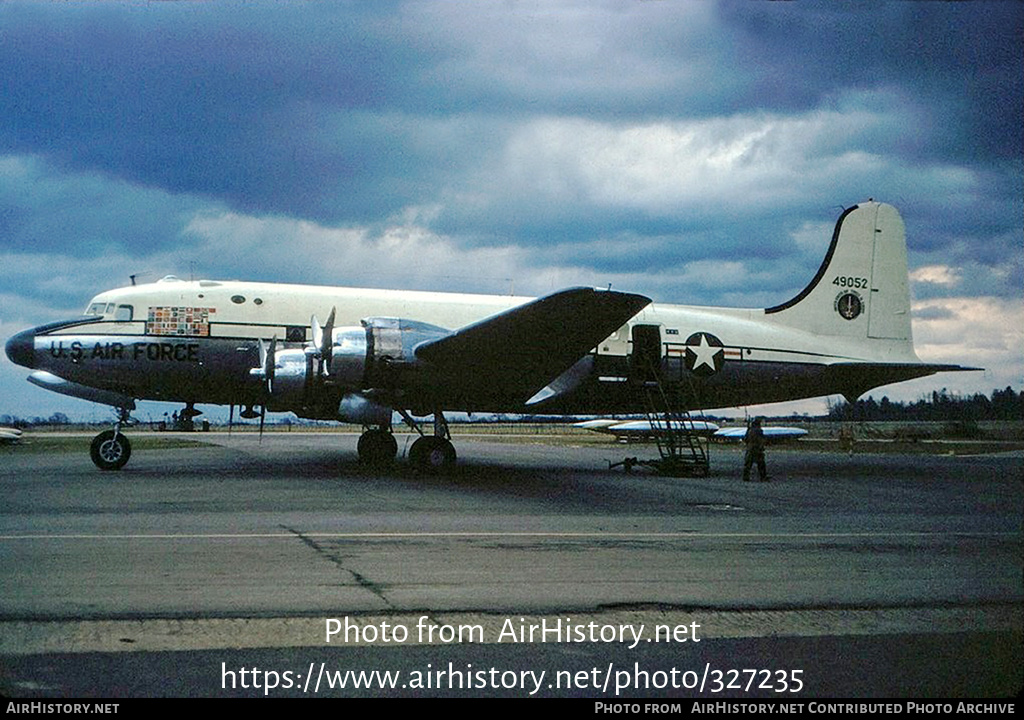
[[5, 200, 976, 470]]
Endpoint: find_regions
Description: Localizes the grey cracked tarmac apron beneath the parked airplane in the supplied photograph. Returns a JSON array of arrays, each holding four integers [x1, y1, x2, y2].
[[0, 432, 1024, 700]]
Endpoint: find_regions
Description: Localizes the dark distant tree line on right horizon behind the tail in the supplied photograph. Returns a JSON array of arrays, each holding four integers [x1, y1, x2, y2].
[[828, 387, 1024, 422]]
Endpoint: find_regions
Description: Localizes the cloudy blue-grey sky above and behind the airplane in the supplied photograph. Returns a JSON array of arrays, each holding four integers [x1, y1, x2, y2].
[[0, 0, 1024, 417]]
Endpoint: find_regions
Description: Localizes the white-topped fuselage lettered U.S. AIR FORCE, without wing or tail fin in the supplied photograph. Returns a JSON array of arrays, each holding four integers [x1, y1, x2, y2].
[[8, 279, 937, 418]]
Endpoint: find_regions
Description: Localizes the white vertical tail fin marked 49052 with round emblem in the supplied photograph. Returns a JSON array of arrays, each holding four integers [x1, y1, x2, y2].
[[765, 201, 912, 343]]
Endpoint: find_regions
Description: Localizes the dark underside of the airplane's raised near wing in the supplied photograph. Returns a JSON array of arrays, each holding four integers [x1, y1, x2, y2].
[[415, 288, 650, 403]]
